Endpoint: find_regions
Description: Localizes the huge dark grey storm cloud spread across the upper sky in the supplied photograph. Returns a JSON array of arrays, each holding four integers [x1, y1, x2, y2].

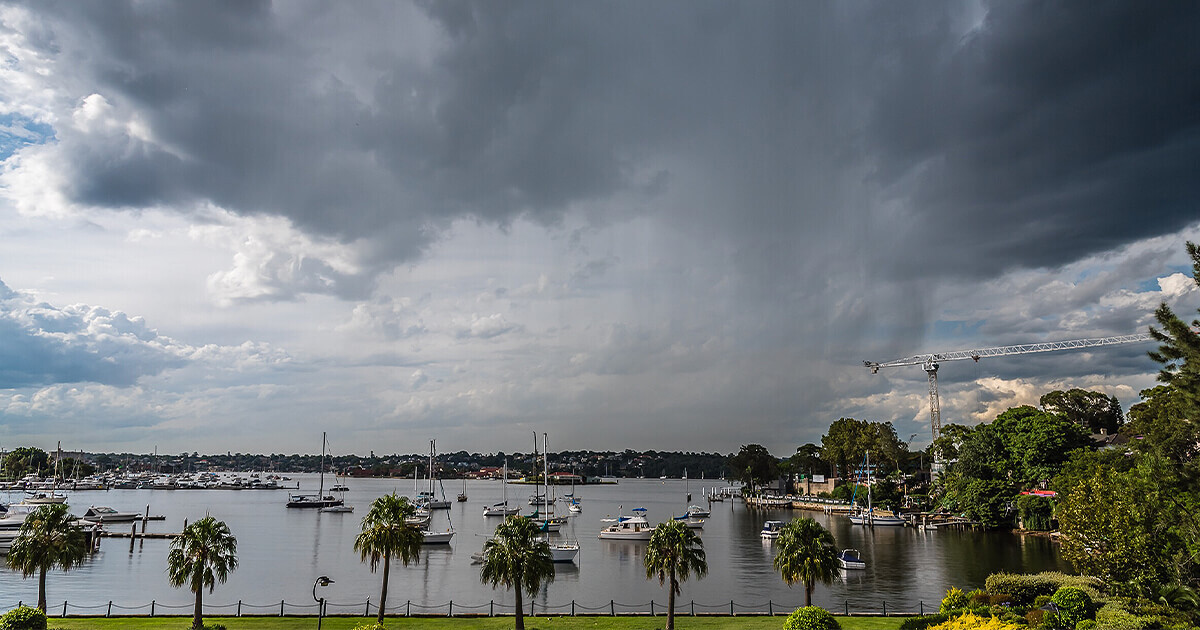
[[9, 2, 1200, 303]]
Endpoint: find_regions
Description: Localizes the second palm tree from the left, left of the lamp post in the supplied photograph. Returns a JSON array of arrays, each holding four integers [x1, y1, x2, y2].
[[167, 516, 238, 630]]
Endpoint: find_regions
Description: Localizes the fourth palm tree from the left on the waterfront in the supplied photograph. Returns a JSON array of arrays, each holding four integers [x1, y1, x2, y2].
[[479, 516, 554, 630]]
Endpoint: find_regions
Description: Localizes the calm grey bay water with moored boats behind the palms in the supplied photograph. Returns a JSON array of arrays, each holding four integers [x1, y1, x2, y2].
[[0, 475, 1069, 613]]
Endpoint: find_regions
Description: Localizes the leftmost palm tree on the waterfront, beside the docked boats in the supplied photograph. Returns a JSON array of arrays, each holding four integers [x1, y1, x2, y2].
[[8, 503, 88, 612]]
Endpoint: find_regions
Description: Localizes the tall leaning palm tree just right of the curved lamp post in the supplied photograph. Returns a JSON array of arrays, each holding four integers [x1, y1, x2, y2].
[[354, 492, 425, 624]]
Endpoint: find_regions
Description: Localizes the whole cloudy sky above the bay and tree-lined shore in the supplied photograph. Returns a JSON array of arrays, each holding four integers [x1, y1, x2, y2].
[[0, 0, 1200, 456]]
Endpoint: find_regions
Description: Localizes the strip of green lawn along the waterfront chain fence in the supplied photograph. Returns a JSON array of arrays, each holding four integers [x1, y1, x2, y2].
[[49, 616, 904, 630]]
